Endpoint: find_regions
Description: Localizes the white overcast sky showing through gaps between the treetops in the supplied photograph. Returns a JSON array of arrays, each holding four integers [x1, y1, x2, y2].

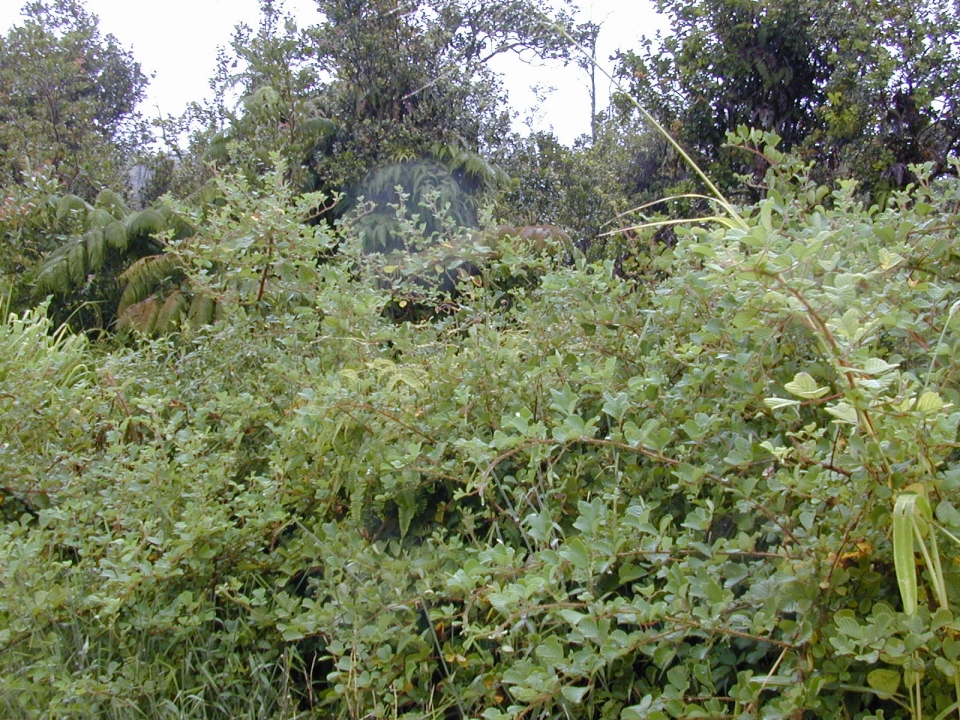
[[0, 0, 664, 143]]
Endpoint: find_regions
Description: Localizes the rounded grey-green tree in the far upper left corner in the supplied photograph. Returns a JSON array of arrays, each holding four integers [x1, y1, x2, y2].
[[0, 0, 147, 200]]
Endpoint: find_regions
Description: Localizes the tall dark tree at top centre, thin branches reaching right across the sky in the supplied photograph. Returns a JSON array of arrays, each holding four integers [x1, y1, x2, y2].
[[309, 0, 568, 184]]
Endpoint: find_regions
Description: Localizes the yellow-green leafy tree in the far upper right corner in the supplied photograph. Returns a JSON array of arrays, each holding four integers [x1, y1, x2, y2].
[[807, 0, 960, 191]]
